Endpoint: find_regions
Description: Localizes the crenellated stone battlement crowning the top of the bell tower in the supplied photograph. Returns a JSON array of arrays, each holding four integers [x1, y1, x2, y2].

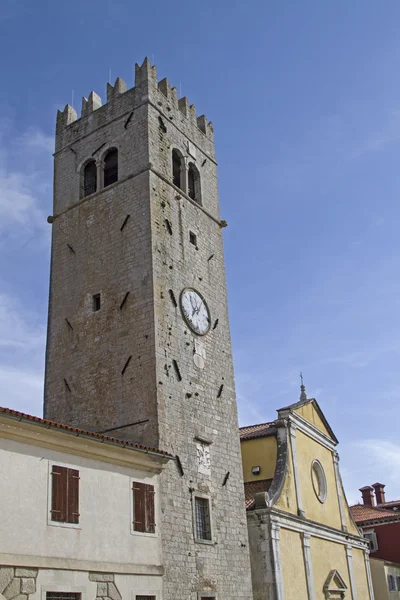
[[56, 57, 214, 146]]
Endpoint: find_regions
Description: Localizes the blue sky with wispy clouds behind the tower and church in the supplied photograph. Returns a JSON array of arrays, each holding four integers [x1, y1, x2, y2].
[[0, 0, 400, 501]]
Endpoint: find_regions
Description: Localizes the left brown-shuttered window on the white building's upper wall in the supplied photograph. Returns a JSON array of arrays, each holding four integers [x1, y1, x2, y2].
[[51, 465, 79, 523]]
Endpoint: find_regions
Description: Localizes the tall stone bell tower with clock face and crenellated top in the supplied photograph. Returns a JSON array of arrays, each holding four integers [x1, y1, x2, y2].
[[44, 59, 252, 600]]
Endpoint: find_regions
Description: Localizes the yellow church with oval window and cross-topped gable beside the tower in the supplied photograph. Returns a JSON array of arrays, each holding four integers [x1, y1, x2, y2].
[[240, 386, 374, 600]]
